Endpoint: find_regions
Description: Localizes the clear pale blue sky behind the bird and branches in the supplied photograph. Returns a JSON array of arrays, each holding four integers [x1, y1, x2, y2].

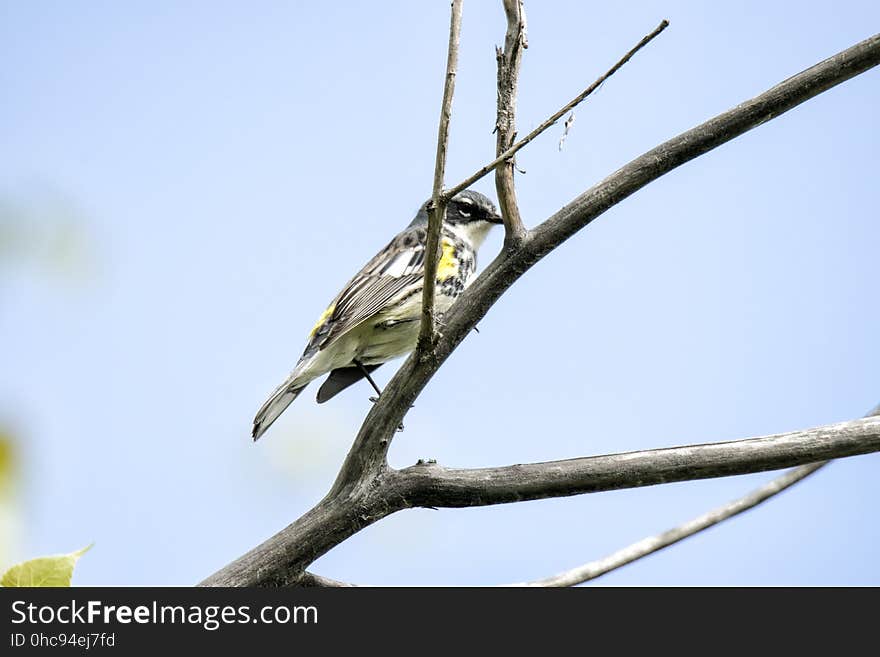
[[0, 0, 880, 585]]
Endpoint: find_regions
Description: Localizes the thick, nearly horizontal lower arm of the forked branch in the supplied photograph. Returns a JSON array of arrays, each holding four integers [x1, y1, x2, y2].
[[387, 417, 880, 508]]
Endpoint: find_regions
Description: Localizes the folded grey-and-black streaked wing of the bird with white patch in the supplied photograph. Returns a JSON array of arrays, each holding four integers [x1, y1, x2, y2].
[[306, 229, 425, 352]]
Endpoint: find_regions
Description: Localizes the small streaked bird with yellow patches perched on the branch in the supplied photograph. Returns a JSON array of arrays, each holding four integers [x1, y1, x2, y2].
[[253, 190, 502, 440]]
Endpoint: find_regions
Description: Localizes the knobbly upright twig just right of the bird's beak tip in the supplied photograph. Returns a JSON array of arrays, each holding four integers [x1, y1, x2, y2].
[[495, 0, 528, 248]]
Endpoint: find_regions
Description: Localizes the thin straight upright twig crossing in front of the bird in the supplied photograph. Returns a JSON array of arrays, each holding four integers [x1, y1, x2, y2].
[[418, 0, 462, 356]]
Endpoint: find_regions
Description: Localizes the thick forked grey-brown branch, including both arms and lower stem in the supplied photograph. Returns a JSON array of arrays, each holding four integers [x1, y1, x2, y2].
[[203, 29, 880, 586]]
